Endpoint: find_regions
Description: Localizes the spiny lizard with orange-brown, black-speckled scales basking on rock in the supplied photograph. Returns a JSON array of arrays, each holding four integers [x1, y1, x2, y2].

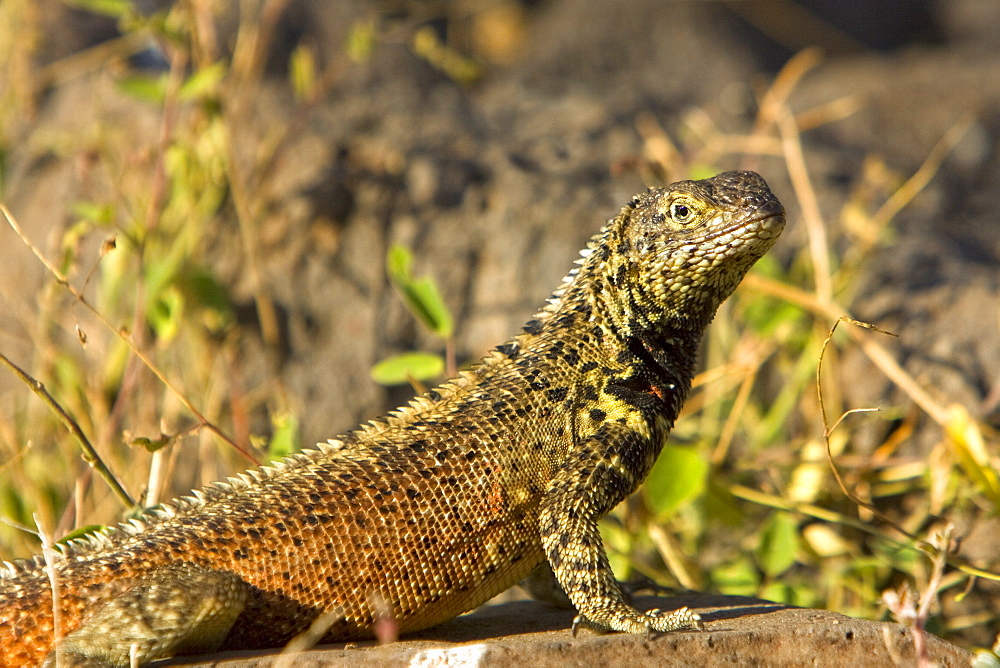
[[0, 171, 785, 666]]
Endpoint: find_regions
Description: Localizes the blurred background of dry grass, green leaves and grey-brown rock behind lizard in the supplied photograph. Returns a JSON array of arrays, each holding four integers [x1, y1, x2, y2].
[[0, 0, 1000, 648]]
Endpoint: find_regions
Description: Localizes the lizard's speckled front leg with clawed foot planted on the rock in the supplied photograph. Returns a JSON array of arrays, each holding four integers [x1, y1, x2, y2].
[[539, 424, 701, 633]]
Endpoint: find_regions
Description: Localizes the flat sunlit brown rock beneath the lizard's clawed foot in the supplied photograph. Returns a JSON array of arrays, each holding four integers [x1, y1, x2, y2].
[[160, 593, 972, 668]]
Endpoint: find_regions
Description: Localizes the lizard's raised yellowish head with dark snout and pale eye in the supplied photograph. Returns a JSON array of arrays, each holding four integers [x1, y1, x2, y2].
[[595, 171, 785, 334]]
